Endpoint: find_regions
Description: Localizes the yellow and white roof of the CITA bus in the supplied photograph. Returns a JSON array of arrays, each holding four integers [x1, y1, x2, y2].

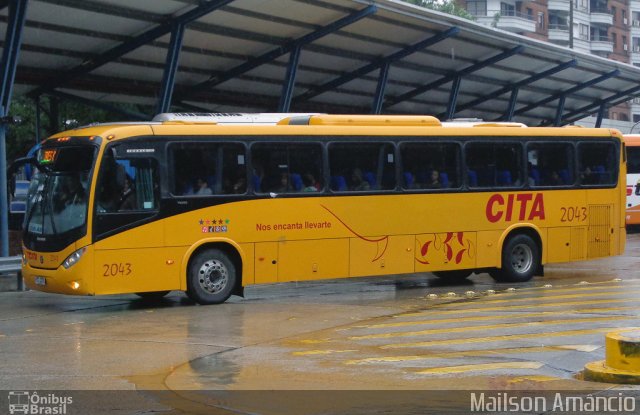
[[50, 113, 624, 145]]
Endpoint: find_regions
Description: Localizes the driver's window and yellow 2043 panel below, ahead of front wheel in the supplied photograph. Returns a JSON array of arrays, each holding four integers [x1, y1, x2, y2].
[[93, 141, 179, 294]]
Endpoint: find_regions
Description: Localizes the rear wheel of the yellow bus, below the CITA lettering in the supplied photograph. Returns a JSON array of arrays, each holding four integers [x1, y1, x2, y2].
[[491, 233, 540, 282]]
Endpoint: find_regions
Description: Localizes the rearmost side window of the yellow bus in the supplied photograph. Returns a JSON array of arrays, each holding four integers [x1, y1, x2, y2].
[[578, 142, 618, 185]]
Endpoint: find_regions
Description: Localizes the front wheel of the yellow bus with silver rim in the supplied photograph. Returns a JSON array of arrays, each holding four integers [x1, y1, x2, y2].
[[187, 249, 236, 305]]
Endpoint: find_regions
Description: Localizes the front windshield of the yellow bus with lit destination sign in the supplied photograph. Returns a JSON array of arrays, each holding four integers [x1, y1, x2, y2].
[[25, 145, 96, 236]]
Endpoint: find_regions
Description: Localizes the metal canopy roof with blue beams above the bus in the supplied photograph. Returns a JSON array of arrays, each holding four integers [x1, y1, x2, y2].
[[0, 0, 640, 125]]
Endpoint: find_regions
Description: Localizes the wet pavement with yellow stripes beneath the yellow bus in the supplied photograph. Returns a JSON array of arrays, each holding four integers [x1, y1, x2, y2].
[[0, 234, 640, 413]]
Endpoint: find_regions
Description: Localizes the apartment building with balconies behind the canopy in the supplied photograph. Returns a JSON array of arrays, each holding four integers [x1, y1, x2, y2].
[[456, 0, 640, 122]]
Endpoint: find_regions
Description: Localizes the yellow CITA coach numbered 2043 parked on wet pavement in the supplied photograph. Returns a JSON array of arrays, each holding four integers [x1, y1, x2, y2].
[[23, 114, 626, 304]]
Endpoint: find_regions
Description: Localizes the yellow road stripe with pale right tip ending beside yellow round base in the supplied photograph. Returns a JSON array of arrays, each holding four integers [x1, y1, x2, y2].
[[344, 344, 601, 365]]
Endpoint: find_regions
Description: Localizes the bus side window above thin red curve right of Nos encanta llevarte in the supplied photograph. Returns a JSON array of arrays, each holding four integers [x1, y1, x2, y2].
[[329, 143, 396, 192]]
